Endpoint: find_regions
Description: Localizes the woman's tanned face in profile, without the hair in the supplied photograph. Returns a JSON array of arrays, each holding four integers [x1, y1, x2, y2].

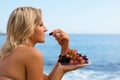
[[33, 22, 47, 43]]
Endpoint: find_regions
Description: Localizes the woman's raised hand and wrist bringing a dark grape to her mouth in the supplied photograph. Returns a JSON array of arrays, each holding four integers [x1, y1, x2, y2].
[[52, 29, 69, 55]]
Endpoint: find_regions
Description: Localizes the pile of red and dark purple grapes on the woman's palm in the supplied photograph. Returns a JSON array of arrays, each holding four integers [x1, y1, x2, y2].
[[58, 49, 88, 65]]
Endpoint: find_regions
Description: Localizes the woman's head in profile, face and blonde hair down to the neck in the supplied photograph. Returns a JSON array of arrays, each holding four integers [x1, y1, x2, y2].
[[7, 7, 47, 46]]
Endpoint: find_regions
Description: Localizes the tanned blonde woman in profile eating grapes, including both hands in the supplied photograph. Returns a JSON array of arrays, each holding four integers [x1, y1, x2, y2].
[[0, 7, 84, 80]]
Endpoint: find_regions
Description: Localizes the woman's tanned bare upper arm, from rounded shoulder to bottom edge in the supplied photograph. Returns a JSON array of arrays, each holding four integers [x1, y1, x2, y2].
[[25, 49, 43, 80]]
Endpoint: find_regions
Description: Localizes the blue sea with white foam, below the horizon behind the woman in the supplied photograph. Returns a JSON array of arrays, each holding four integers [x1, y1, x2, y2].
[[0, 34, 120, 80]]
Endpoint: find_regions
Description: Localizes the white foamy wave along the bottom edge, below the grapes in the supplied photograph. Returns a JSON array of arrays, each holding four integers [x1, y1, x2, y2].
[[63, 70, 120, 80]]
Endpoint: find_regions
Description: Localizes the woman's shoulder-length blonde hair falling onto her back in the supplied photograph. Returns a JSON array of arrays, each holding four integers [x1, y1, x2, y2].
[[0, 7, 42, 58]]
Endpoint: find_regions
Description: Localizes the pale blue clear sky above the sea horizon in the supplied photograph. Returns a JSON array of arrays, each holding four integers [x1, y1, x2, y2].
[[0, 0, 120, 34]]
